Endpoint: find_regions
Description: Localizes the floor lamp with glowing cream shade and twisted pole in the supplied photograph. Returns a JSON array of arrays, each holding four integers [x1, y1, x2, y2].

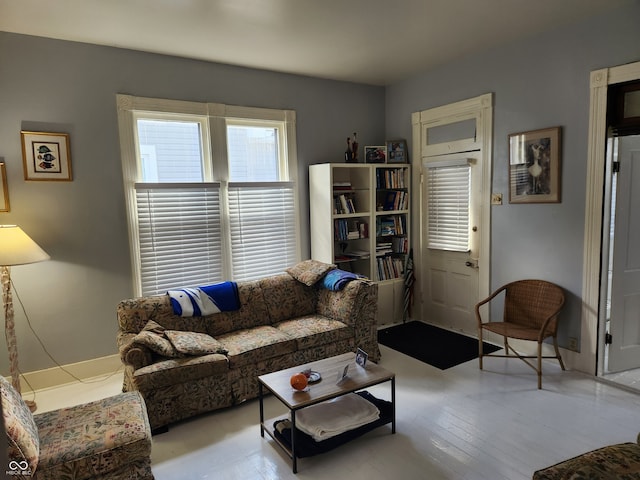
[[0, 225, 49, 411]]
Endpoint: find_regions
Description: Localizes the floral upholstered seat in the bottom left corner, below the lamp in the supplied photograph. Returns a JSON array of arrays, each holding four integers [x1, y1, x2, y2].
[[35, 392, 151, 480]]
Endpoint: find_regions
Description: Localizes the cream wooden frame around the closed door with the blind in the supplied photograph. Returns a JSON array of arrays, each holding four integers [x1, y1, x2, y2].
[[411, 93, 493, 326]]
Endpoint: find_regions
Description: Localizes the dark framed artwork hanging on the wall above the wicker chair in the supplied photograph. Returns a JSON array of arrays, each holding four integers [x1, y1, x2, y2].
[[509, 127, 562, 203]]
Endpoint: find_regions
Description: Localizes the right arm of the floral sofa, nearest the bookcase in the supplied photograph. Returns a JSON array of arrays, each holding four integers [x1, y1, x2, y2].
[[317, 279, 380, 362]]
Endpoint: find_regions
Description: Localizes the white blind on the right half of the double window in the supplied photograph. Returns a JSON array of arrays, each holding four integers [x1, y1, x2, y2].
[[228, 182, 296, 280]]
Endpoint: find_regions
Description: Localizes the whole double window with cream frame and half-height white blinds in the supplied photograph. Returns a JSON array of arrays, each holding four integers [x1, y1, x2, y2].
[[118, 95, 300, 295]]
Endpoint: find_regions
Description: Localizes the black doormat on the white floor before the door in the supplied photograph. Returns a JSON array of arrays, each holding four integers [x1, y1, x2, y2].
[[378, 321, 500, 370]]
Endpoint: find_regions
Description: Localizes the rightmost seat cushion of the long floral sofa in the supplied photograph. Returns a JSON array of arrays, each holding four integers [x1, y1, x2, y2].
[[274, 315, 353, 350]]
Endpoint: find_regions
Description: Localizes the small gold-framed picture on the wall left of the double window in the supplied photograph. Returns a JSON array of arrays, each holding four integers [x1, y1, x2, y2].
[[20, 131, 72, 182]]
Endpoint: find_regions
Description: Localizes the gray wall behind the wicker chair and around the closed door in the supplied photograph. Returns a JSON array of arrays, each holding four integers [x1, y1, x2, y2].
[[386, 3, 640, 345]]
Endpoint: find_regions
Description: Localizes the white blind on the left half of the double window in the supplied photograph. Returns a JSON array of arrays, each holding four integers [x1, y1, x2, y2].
[[135, 183, 223, 295]]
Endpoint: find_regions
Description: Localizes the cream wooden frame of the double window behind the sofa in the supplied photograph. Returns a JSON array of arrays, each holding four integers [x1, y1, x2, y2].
[[116, 94, 301, 296]]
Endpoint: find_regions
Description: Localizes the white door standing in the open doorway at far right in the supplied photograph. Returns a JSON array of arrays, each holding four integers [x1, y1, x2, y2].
[[608, 141, 640, 373]]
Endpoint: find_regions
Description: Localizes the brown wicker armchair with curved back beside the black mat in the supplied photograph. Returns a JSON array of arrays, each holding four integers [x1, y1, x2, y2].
[[475, 280, 565, 389]]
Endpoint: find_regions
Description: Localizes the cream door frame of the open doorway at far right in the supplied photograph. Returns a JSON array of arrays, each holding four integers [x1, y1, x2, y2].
[[584, 62, 640, 376]]
